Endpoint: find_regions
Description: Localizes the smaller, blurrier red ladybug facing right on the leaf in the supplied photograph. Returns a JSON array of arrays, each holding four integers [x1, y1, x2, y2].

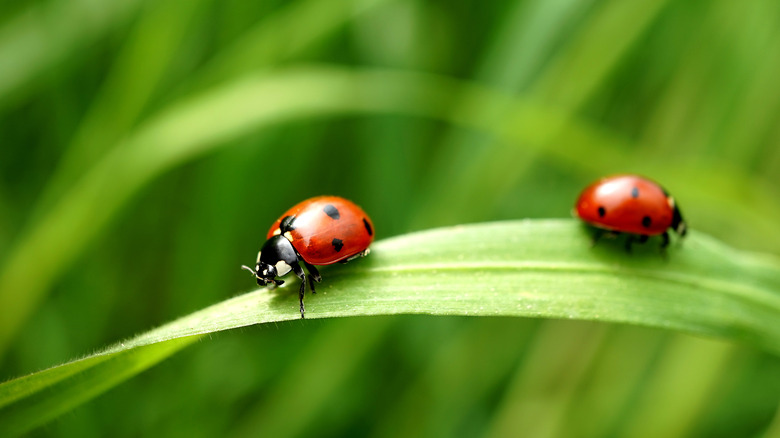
[[574, 175, 686, 251]]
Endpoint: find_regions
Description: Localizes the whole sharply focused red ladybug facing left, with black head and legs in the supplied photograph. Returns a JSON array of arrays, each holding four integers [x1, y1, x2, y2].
[[241, 196, 374, 318]]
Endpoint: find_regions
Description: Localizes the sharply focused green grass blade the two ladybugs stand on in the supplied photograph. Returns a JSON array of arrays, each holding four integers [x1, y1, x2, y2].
[[0, 220, 780, 434]]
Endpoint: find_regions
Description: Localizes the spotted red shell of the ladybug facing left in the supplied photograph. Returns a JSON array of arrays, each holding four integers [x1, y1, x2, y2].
[[267, 196, 374, 265]]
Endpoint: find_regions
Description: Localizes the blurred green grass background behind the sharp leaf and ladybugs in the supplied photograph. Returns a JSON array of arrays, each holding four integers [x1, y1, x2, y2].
[[0, 0, 780, 437]]
